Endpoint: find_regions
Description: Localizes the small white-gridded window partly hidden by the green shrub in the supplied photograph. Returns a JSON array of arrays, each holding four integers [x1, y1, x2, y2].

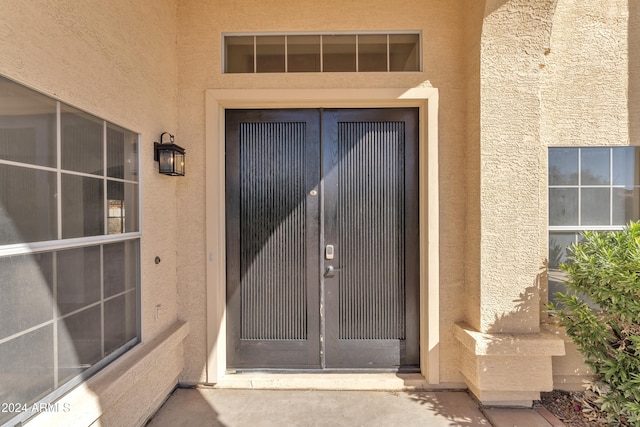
[[549, 147, 640, 299]]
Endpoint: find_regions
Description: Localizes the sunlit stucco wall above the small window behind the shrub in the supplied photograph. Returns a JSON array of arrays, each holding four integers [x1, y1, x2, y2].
[[539, 0, 640, 389]]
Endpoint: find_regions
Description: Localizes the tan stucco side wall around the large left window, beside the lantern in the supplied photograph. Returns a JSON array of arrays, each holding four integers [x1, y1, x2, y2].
[[0, 0, 182, 425]]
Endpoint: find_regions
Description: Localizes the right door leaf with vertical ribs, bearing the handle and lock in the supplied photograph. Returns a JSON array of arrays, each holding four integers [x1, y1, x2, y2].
[[322, 109, 419, 368]]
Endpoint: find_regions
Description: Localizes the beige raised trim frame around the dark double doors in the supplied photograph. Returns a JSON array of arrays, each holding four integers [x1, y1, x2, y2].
[[205, 87, 440, 385]]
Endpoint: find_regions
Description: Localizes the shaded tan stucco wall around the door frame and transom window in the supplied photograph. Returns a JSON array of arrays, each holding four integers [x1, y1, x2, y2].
[[178, 0, 465, 382]]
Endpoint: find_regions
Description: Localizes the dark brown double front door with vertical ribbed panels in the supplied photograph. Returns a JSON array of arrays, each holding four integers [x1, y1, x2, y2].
[[226, 109, 420, 370]]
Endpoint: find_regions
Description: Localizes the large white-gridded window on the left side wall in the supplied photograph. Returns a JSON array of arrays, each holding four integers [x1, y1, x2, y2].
[[0, 77, 141, 425]]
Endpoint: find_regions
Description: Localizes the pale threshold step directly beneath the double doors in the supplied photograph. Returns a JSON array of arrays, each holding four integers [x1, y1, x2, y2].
[[215, 371, 456, 391]]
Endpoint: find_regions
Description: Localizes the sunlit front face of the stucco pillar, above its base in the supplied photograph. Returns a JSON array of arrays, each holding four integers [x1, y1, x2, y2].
[[466, 0, 555, 333]]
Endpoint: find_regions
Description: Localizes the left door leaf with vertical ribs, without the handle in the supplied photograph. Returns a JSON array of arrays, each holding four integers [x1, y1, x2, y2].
[[226, 110, 320, 368]]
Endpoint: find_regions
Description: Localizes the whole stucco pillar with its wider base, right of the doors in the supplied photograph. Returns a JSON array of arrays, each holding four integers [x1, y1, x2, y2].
[[455, 0, 564, 406]]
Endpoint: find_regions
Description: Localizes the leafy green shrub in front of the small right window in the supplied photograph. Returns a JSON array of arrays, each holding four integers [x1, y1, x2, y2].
[[548, 223, 640, 426]]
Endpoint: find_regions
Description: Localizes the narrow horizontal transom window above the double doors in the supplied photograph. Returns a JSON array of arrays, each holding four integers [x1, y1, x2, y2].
[[223, 32, 422, 74]]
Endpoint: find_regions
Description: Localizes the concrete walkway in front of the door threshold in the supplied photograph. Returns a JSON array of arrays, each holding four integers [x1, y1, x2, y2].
[[148, 389, 562, 427]]
